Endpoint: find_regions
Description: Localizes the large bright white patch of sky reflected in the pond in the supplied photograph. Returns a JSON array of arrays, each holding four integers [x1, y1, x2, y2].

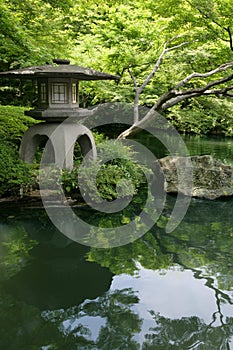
[[111, 267, 224, 324]]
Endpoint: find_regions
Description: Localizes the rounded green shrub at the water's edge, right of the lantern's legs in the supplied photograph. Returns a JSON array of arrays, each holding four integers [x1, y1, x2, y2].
[[62, 141, 148, 202]]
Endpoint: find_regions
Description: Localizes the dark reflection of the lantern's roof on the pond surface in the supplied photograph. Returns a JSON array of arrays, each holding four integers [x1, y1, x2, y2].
[[4, 244, 112, 310]]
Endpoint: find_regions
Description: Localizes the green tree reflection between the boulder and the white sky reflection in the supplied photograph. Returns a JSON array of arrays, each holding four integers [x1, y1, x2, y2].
[[88, 198, 233, 291]]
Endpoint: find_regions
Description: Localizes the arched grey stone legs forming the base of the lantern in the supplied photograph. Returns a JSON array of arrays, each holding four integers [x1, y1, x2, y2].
[[19, 121, 97, 169]]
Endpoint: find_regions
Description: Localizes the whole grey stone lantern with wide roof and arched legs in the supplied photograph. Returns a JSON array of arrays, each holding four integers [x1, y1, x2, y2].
[[0, 59, 119, 169]]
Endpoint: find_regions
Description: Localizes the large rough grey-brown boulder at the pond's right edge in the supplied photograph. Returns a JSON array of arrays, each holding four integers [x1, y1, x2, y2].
[[155, 155, 233, 199]]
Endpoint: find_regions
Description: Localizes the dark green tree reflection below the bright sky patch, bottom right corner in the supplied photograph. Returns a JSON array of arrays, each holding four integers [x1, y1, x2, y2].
[[142, 311, 233, 350]]
